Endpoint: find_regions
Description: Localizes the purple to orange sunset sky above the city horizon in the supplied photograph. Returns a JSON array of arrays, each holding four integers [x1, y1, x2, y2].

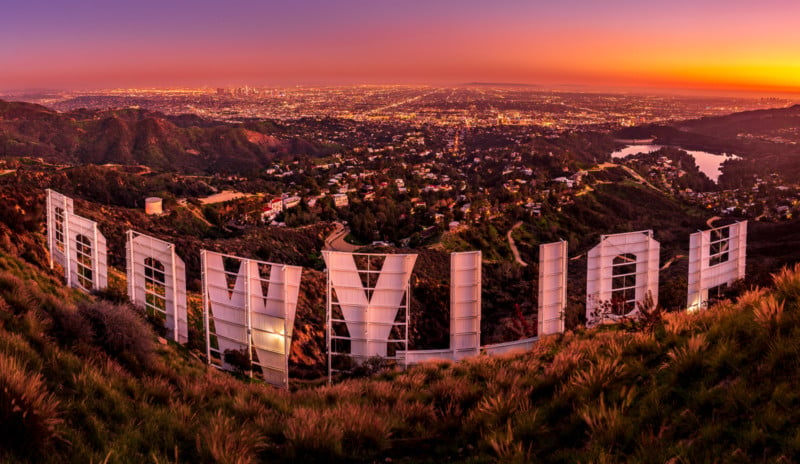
[[0, 0, 800, 92]]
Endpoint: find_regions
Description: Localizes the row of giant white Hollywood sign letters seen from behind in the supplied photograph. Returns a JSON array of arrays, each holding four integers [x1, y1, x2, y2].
[[42, 190, 747, 387]]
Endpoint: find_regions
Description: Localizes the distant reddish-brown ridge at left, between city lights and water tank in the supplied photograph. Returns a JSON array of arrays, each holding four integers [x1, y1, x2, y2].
[[0, 100, 334, 173]]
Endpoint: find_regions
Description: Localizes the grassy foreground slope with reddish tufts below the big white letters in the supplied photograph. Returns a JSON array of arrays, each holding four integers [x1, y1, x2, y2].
[[0, 214, 800, 463]]
